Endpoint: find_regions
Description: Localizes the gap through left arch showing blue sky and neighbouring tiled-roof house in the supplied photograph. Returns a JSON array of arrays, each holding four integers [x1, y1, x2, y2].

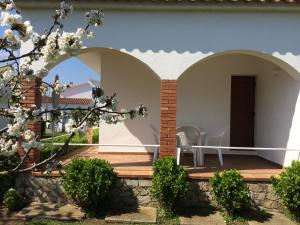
[[41, 57, 100, 139]]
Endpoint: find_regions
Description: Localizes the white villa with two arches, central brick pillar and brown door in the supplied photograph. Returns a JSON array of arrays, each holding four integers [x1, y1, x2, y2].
[[16, 0, 300, 166]]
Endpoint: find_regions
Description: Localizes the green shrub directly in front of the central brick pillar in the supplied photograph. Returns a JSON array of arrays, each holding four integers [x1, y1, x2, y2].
[[151, 157, 188, 214]]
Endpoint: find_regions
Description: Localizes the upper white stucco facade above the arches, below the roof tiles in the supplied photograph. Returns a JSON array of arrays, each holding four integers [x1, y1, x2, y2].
[[23, 4, 300, 79]]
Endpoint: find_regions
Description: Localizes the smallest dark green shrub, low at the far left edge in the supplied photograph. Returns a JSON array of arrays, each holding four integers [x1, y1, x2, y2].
[[3, 188, 25, 212]]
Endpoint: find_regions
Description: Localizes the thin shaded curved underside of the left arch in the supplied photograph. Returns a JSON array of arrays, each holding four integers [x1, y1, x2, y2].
[[45, 47, 161, 80]]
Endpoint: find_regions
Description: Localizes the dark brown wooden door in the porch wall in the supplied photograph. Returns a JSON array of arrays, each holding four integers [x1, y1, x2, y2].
[[230, 76, 255, 147]]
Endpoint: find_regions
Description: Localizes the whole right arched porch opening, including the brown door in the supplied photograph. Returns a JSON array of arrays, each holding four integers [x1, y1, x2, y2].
[[177, 51, 300, 165]]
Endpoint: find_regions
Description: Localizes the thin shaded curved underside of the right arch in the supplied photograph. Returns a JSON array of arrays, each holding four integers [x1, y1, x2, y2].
[[177, 49, 300, 81]]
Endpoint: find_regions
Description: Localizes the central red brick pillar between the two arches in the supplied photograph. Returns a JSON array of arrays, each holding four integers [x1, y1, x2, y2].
[[159, 80, 176, 157]]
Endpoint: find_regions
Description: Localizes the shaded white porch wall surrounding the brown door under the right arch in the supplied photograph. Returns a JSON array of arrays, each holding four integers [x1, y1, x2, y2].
[[177, 54, 300, 165]]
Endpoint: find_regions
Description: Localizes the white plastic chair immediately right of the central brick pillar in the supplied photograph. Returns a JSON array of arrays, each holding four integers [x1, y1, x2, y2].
[[176, 126, 201, 167]]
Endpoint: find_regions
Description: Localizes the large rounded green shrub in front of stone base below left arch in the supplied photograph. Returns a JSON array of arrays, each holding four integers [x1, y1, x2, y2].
[[62, 159, 115, 213]]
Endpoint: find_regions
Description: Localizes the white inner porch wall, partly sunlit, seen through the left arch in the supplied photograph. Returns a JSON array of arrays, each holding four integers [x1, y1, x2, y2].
[[47, 48, 160, 152]]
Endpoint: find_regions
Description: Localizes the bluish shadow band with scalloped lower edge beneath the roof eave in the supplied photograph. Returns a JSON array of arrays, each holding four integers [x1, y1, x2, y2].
[[92, 11, 300, 55]]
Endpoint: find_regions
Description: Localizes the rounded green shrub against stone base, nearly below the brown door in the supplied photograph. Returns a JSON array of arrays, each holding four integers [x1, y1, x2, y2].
[[209, 170, 250, 216]]
